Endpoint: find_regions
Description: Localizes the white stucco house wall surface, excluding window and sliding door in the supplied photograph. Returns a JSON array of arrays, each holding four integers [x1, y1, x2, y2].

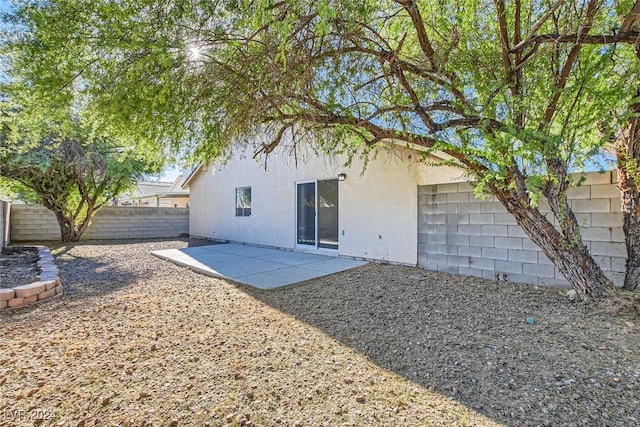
[[190, 145, 417, 264]]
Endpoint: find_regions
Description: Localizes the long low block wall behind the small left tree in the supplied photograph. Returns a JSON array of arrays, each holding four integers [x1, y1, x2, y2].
[[11, 205, 189, 242]]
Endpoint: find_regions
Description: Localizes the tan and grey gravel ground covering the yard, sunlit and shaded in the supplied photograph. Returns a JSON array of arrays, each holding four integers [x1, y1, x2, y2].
[[0, 239, 640, 427]]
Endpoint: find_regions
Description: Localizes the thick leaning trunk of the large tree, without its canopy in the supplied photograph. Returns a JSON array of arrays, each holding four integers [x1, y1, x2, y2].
[[495, 190, 613, 302]]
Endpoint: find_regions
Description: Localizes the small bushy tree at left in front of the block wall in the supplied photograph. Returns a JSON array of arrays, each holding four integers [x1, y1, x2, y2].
[[0, 125, 160, 242]]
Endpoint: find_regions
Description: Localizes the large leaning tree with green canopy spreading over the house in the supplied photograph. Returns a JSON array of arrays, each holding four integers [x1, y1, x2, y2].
[[6, 0, 637, 301]]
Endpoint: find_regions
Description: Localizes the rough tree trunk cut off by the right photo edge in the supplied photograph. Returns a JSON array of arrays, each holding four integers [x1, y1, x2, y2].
[[614, 90, 640, 290]]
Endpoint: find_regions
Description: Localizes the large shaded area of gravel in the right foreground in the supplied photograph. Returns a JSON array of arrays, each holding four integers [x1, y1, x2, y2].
[[238, 264, 640, 426]]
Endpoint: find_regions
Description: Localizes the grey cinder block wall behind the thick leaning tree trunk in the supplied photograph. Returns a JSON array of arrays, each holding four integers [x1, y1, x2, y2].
[[418, 172, 626, 286]]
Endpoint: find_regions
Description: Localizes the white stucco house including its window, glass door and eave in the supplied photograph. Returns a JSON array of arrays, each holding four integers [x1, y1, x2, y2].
[[180, 146, 462, 265]]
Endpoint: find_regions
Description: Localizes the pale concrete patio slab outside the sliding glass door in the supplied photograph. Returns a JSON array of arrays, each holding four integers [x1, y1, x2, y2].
[[151, 243, 366, 289]]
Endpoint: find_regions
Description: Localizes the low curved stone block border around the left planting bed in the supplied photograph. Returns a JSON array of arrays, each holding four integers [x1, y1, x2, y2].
[[0, 246, 62, 311]]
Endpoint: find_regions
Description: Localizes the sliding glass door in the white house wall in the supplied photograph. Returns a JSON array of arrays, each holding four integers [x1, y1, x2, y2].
[[296, 179, 338, 249]]
